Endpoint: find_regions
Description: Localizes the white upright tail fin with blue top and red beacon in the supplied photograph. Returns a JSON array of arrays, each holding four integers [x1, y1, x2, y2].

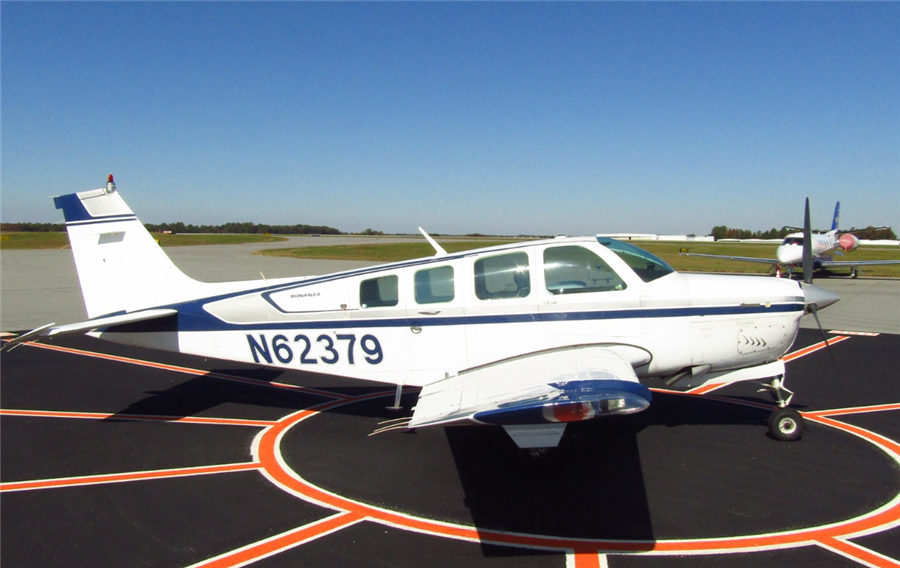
[[53, 175, 206, 318]]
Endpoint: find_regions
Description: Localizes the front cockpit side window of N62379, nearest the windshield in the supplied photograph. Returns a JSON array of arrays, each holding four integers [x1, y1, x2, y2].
[[544, 246, 625, 294]]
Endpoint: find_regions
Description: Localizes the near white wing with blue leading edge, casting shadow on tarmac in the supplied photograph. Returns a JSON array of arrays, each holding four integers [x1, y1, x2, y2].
[[409, 344, 651, 428]]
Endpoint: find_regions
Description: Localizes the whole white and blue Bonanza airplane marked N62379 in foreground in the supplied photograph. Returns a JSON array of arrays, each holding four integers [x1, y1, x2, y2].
[[11, 176, 839, 457]]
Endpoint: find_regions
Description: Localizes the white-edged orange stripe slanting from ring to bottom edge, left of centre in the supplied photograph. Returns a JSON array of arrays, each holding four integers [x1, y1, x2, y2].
[[188, 513, 364, 568]]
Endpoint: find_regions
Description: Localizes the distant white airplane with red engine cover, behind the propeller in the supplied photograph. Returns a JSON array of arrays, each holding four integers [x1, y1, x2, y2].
[[681, 201, 900, 278]]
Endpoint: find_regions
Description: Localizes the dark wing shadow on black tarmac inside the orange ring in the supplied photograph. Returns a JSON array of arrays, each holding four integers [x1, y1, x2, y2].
[[444, 426, 653, 556]]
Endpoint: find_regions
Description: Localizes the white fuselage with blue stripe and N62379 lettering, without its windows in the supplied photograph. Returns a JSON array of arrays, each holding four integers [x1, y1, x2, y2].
[[101, 238, 803, 385]]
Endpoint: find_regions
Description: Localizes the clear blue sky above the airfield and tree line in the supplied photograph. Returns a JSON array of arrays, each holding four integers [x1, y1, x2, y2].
[[0, 0, 900, 235]]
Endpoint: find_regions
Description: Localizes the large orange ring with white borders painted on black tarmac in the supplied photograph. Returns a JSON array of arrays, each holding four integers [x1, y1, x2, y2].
[[253, 392, 900, 566]]
